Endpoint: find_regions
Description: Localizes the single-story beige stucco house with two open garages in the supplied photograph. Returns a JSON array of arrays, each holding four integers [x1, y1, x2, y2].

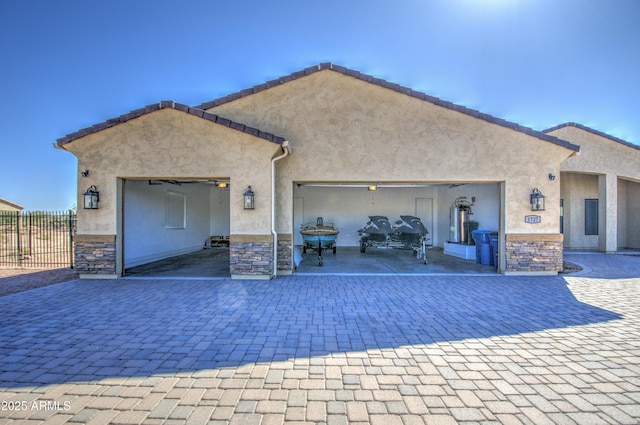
[[55, 63, 640, 279]]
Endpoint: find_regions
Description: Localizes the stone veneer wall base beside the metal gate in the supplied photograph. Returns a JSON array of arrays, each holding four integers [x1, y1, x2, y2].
[[74, 235, 116, 278]]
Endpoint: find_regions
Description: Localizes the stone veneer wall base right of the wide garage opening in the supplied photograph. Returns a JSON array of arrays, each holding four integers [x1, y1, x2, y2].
[[505, 234, 563, 275]]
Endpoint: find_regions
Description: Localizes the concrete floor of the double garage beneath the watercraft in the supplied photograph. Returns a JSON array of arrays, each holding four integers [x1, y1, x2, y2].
[[296, 246, 496, 275]]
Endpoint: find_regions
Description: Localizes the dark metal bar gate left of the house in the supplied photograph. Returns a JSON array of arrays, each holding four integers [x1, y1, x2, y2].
[[0, 210, 76, 268]]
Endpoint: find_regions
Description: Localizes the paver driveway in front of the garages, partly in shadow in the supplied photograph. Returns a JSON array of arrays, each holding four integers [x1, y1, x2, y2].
[[0, 256, 640, 425]]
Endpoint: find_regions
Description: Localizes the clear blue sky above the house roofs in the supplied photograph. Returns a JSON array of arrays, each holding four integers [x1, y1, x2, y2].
[[0, 0, 640, 210]]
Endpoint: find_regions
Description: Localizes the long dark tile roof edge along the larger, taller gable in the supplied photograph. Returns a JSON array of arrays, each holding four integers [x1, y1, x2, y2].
[[196, 62, 580, 152]]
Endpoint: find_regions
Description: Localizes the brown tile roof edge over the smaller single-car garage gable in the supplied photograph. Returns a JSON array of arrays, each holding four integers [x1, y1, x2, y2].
[[56, 100, 285, 147]]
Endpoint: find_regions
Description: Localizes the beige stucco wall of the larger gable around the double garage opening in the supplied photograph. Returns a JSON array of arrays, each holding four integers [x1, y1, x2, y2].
[[209, 70, 572, 233]]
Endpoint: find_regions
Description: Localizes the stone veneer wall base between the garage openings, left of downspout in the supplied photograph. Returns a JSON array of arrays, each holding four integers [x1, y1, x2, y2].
[[229, 235, 273, 279]]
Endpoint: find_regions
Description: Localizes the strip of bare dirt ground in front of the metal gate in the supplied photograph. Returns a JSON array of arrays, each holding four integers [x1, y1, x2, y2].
[[0, 268, 78, 297]]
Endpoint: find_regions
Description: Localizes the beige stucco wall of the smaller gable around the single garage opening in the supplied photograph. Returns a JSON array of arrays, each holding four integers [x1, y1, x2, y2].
[[59, 109, 281, 235]]
